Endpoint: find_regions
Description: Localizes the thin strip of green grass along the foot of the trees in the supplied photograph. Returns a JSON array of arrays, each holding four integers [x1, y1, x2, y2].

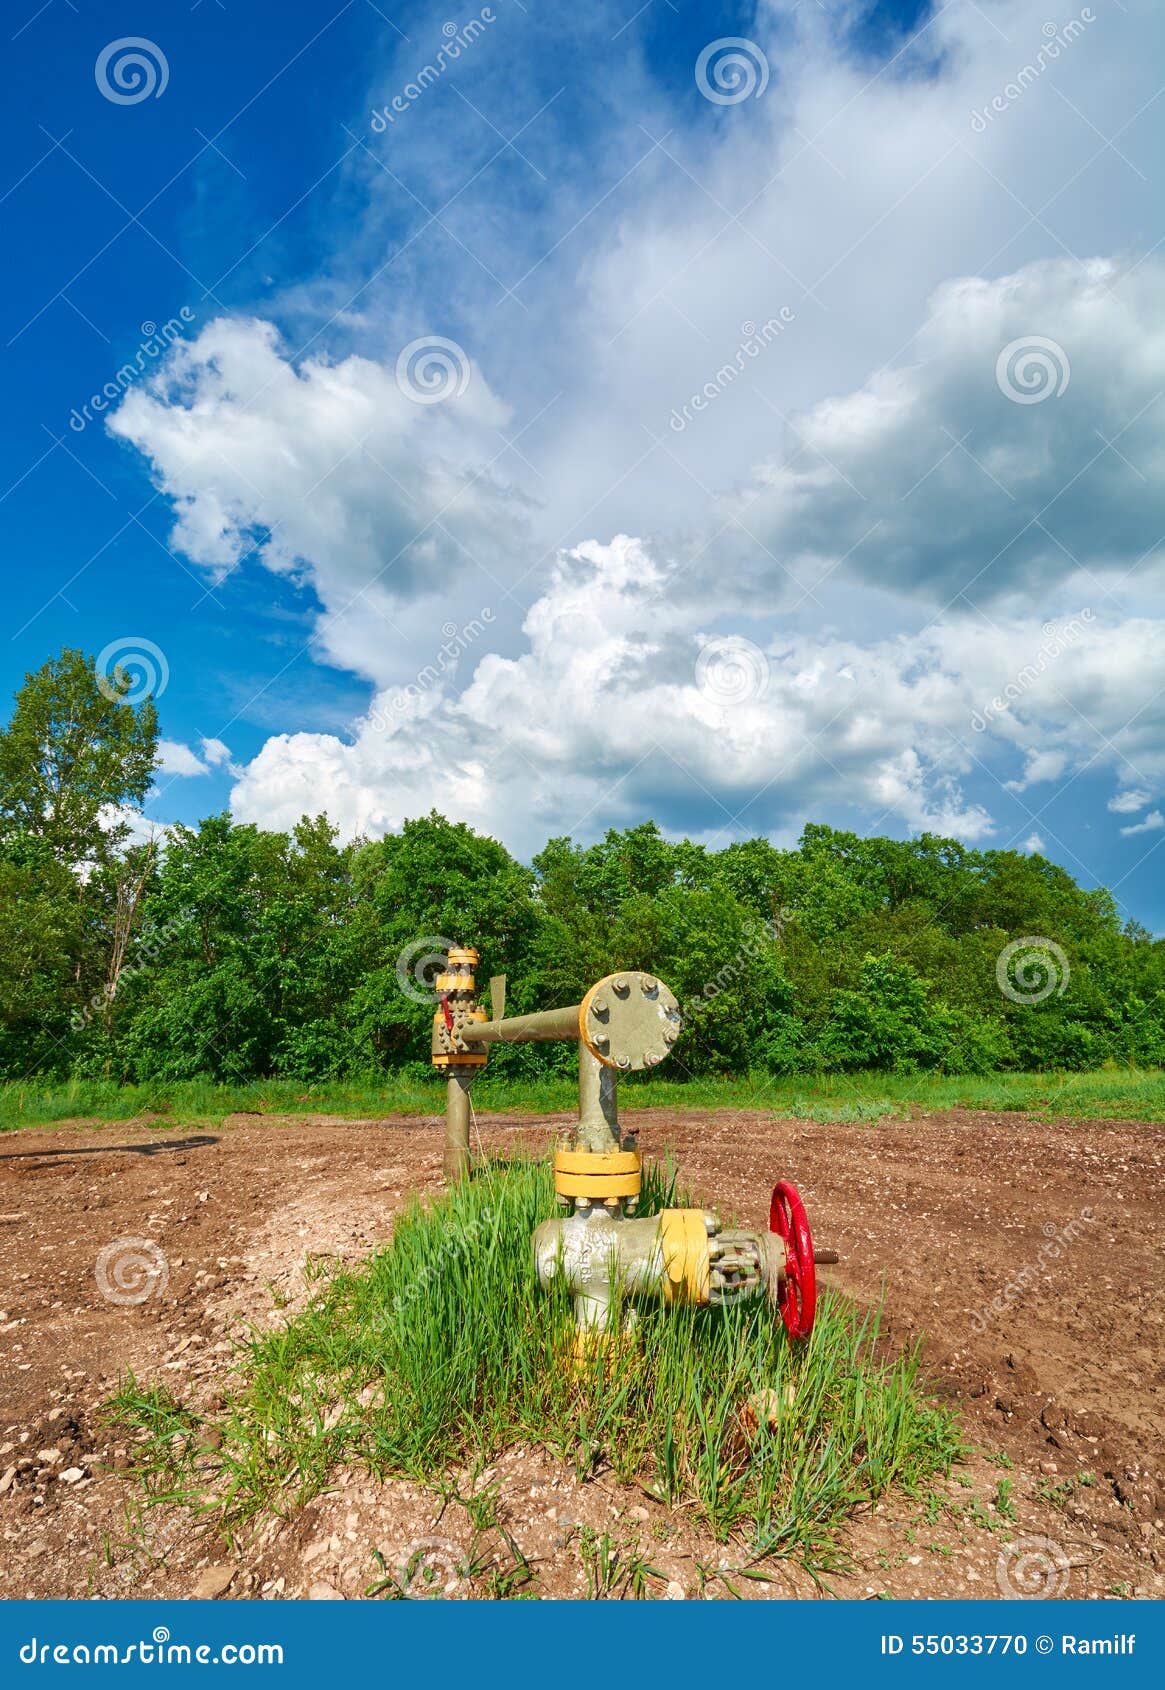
[[0, 1068, 1165, 1131]]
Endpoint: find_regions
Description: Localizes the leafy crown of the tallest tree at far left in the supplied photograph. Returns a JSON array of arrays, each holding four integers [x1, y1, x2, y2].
[[0, 647, 157, 867]]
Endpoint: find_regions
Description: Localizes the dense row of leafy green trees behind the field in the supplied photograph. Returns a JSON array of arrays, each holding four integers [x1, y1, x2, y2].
[[0, 651, 1165, 1082]]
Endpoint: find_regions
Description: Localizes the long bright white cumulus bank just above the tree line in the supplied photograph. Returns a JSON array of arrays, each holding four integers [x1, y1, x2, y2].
[[232, 536, 1165, 850]]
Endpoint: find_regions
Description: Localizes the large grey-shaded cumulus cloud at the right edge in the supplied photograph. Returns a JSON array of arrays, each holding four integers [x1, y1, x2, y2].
[[725, 259, 1165, 605]]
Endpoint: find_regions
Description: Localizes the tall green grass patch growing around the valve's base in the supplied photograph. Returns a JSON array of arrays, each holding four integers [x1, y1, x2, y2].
[[112, 1161, 960, 1589]]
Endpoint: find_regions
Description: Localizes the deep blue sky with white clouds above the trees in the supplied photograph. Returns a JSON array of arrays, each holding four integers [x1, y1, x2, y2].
[[0, 0, 1165, 930]]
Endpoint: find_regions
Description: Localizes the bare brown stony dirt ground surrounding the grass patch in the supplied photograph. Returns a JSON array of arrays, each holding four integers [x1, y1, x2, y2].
[[0, 1110, 1165, 1599]]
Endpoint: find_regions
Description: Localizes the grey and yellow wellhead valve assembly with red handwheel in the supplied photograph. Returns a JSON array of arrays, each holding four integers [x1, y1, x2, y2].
[[433, 948, 837, 1359]]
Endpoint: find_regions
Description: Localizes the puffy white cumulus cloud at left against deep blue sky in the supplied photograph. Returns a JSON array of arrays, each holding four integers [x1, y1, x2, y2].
[[110, 318, 526, 681]]
